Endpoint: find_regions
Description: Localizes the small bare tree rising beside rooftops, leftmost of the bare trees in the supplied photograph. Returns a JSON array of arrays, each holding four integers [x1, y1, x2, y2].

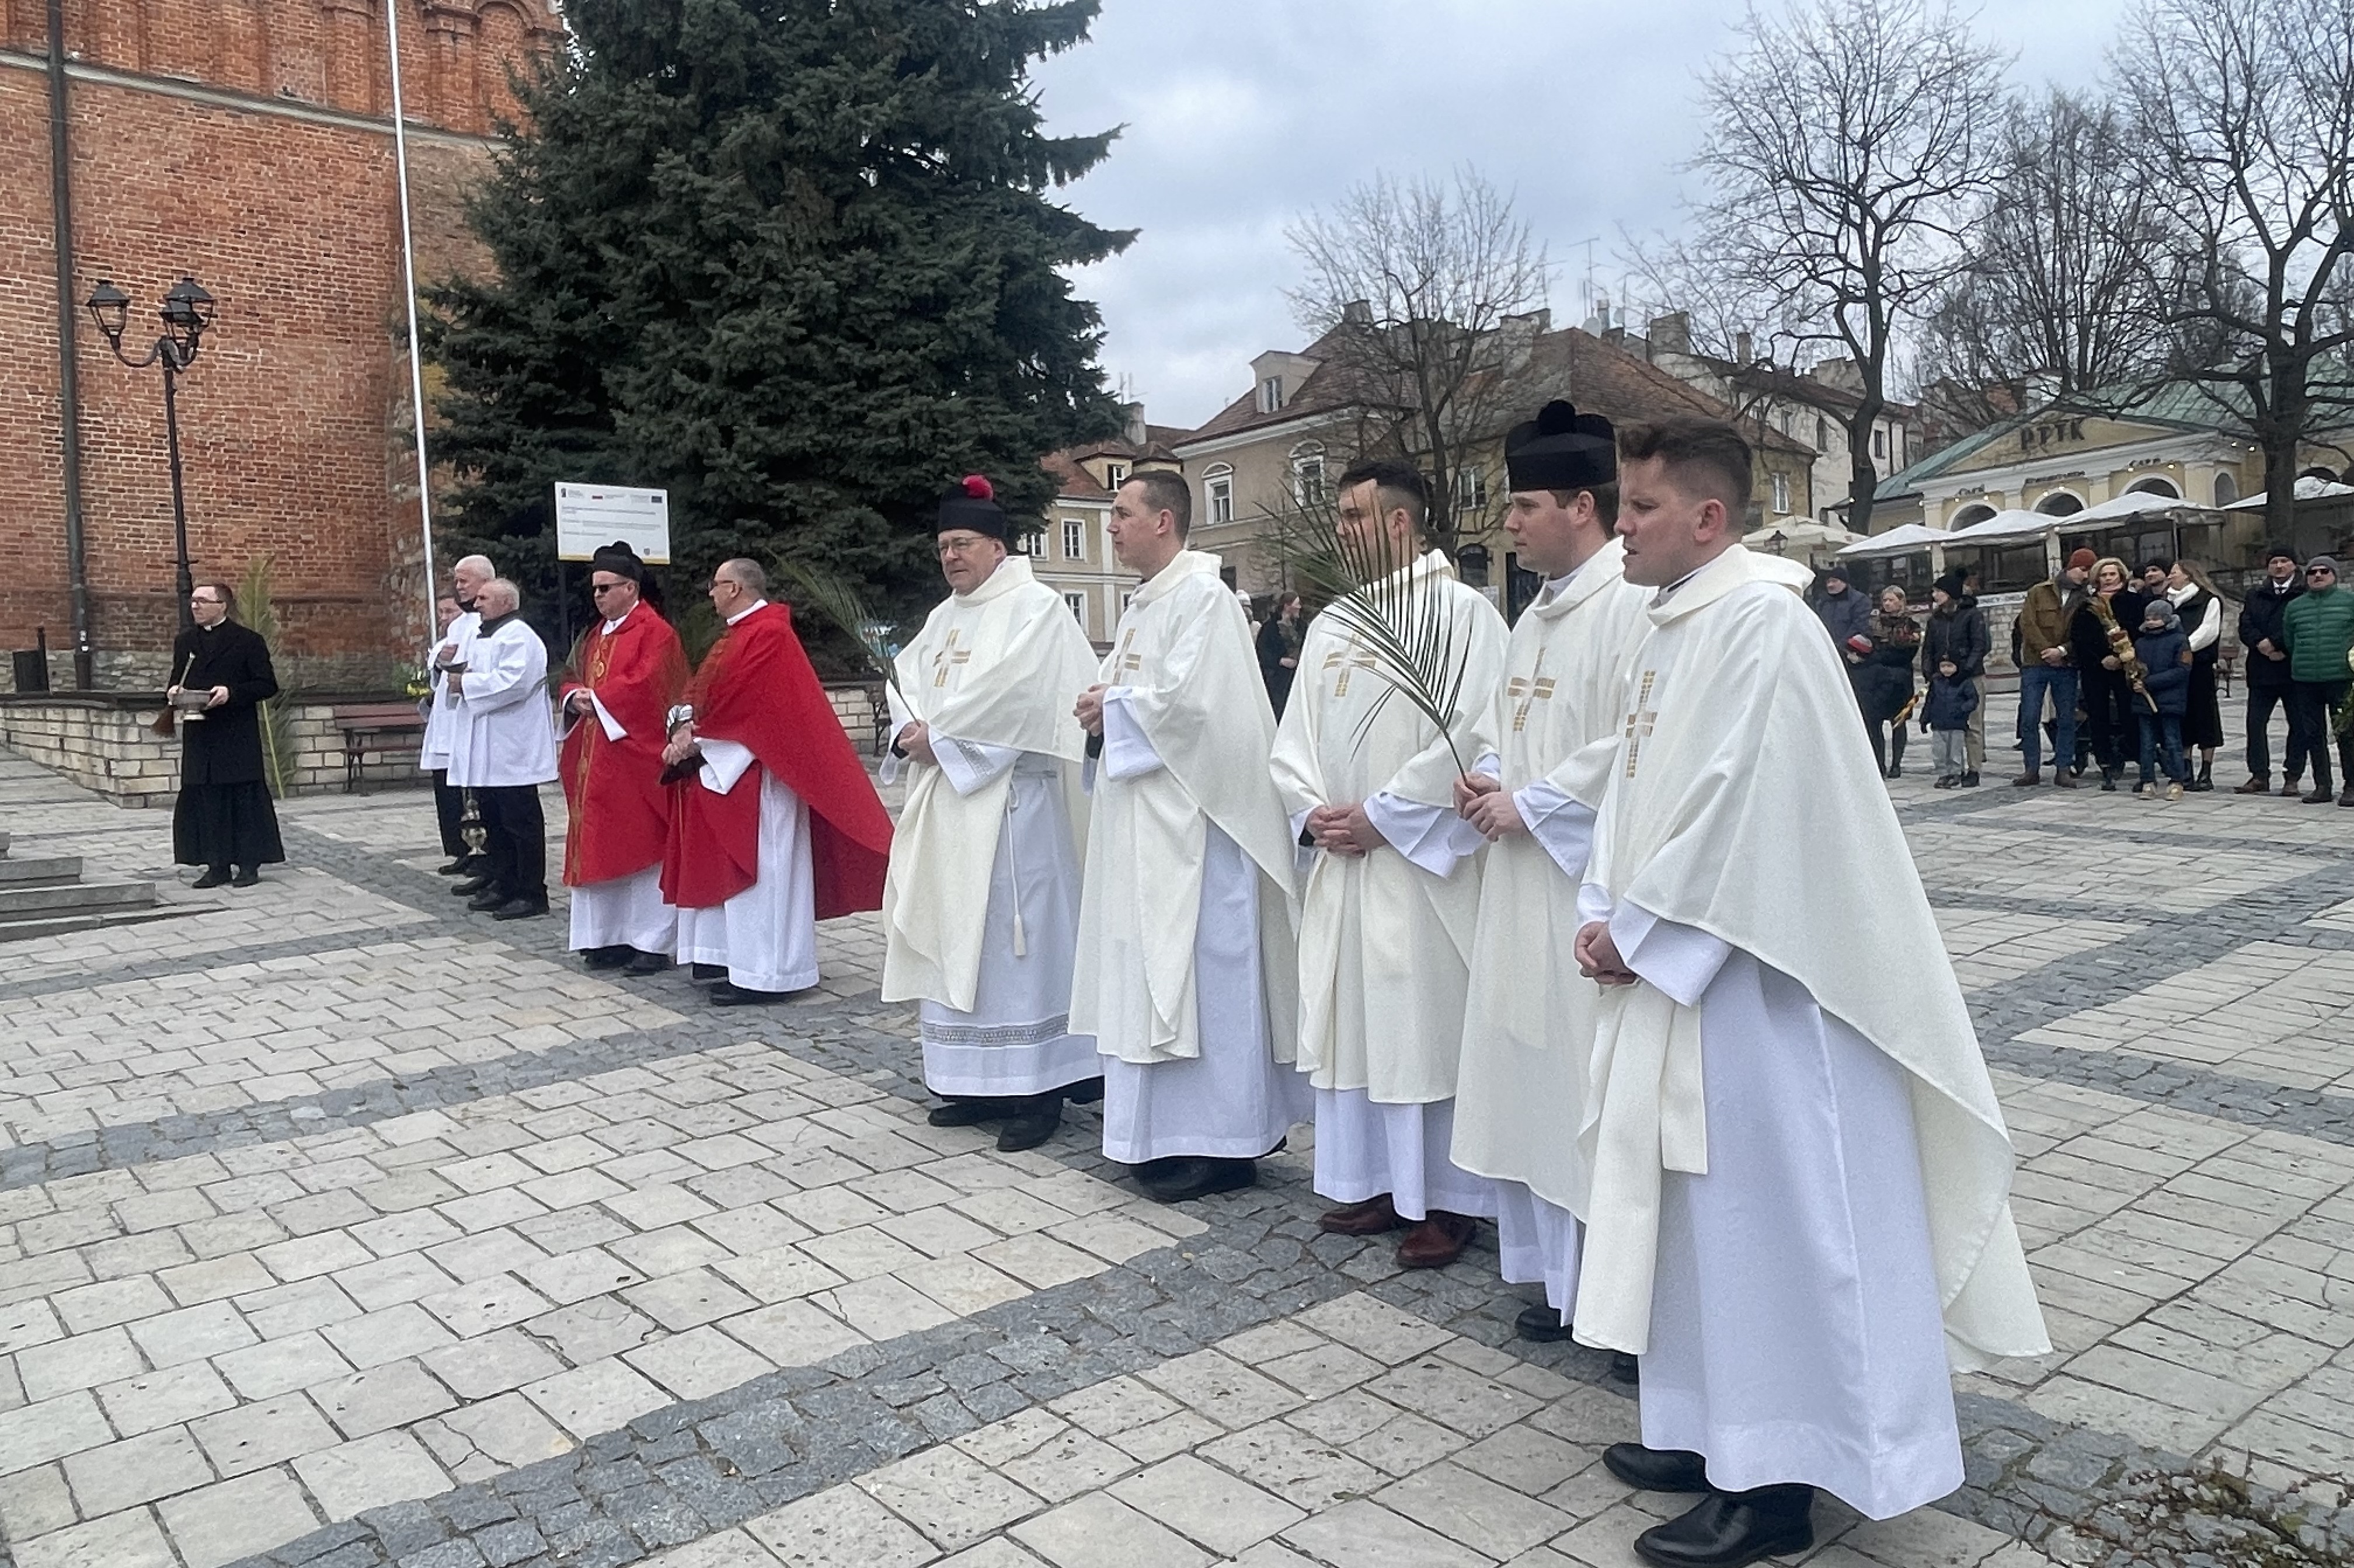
[[1285, 167, 1551, 553]]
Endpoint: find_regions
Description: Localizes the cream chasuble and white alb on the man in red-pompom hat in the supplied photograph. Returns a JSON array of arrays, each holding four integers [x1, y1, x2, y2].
[[883, 558, 1099, 1095]]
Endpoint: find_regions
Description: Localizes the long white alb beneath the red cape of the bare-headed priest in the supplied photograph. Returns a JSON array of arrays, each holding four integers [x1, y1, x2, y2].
[[678, 598, 817, 991]]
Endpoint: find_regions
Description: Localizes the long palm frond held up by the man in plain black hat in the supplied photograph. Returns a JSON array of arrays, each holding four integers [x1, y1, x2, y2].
[[1290, 518, 1471, 775]]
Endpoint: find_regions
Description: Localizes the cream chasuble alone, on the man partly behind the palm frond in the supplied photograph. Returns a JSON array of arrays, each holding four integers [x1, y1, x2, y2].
[[1273, 551, 1509, 1104]]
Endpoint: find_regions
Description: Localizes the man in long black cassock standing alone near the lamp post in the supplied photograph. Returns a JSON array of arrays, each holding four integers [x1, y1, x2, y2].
[[172, 581, 287, 887]]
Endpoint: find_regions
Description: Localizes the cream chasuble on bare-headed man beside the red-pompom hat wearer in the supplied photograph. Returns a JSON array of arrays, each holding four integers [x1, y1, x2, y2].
[[1071, 551, 1297, 1068]]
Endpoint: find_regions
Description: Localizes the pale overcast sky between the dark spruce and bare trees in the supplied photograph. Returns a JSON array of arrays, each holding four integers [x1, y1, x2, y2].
[[1036, 0, 2123, 426]]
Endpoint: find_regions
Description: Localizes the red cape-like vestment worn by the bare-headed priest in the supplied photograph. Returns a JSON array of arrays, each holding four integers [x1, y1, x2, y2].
[[661, 602, 890, 921]]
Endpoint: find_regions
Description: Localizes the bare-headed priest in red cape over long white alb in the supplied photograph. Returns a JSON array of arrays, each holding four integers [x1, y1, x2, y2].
[[661, 560, 890, 1008]]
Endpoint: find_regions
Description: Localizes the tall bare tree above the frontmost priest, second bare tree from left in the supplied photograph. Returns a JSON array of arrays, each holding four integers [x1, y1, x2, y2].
[[1693, 0, 2008, 532]]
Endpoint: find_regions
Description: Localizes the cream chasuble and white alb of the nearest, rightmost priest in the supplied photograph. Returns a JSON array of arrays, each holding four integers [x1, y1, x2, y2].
[[1572, 549, 2048, 1518]]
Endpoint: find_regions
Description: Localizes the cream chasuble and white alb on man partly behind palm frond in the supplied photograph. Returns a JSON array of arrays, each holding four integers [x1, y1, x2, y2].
[[1273, 551, 1509, 1219]]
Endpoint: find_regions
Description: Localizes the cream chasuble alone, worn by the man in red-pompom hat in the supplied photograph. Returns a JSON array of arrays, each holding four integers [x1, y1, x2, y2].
[[883, 556, 1095, 1022]]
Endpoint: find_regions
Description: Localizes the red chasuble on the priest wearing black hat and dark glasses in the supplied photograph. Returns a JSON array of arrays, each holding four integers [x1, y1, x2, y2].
[[558, 605, 687, 887]]
